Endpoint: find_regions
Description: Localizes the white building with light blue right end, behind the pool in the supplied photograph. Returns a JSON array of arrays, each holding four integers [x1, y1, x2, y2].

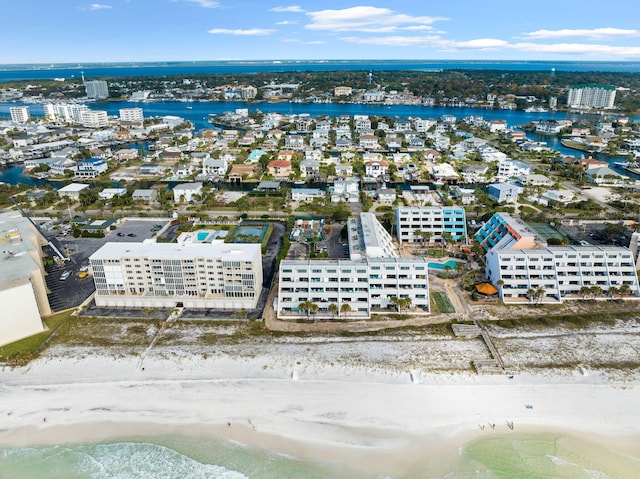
[[396, 206, 467, 243]]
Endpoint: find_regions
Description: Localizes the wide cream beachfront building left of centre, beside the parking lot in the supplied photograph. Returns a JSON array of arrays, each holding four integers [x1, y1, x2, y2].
[[89, 241, 262, 310]]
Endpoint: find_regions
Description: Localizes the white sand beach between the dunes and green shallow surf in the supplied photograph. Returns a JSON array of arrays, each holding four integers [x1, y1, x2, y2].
[[0, 341, 640, 474]]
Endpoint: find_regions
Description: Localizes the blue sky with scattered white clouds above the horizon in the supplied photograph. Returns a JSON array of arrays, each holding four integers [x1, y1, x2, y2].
[[0, 0, 640, 64]]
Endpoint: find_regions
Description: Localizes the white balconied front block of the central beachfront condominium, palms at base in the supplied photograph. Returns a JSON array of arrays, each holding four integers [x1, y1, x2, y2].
[[276, 257, 429, 319]]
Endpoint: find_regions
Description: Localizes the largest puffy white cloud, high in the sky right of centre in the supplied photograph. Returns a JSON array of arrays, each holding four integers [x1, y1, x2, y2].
[[306, 6, 448, 32]]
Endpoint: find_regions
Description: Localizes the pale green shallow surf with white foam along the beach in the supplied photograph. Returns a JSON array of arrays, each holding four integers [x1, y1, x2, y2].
[[0, 433, 640, 479]]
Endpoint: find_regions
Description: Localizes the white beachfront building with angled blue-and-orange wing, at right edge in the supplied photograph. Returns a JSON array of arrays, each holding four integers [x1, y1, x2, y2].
[[476, 213, 640, 303]]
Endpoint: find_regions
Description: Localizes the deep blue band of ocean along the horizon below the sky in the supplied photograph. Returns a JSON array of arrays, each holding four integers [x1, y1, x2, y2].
[[0, 60, 640, 82]]
